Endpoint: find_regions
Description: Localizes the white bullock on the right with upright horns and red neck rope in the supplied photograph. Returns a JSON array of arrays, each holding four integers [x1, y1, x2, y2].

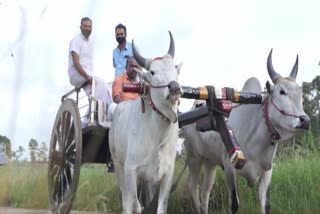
[[184, 50, 309, 214]]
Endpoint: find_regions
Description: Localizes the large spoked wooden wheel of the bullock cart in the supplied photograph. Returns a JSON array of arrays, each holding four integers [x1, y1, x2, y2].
[[48, 99, 82, 214]]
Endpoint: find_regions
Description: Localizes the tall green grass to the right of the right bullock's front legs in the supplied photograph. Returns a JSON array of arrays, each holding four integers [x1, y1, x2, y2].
[[270, 150, 320, 214]]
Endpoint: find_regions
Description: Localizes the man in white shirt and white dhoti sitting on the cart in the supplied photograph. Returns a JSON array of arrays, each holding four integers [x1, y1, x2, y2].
[[68, 17, 112, 104]]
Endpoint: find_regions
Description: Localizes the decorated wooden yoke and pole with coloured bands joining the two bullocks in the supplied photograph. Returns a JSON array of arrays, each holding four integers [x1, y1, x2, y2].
[[122, 83, 262, 169]]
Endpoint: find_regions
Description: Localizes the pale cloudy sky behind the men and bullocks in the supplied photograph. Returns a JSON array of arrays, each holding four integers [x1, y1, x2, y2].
[[0, 0, 320, 155]]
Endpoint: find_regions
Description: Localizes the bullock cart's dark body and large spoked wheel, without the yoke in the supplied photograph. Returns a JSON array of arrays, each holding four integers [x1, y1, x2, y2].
[[48, 83, 111, 214]]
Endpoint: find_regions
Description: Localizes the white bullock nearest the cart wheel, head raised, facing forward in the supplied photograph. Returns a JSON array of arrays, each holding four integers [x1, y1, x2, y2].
[[109, 32, 181, 214]]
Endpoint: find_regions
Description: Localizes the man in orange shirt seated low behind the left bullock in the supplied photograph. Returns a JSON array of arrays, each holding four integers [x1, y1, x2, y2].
[[112, 57, 141, 104]]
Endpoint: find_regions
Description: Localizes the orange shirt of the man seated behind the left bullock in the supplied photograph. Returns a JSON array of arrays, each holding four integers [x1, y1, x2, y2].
[[112, 72, 139, 100]]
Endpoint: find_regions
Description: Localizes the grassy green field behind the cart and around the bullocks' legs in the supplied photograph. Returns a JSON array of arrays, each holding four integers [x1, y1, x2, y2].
[[0, 148, 320, 214]]
